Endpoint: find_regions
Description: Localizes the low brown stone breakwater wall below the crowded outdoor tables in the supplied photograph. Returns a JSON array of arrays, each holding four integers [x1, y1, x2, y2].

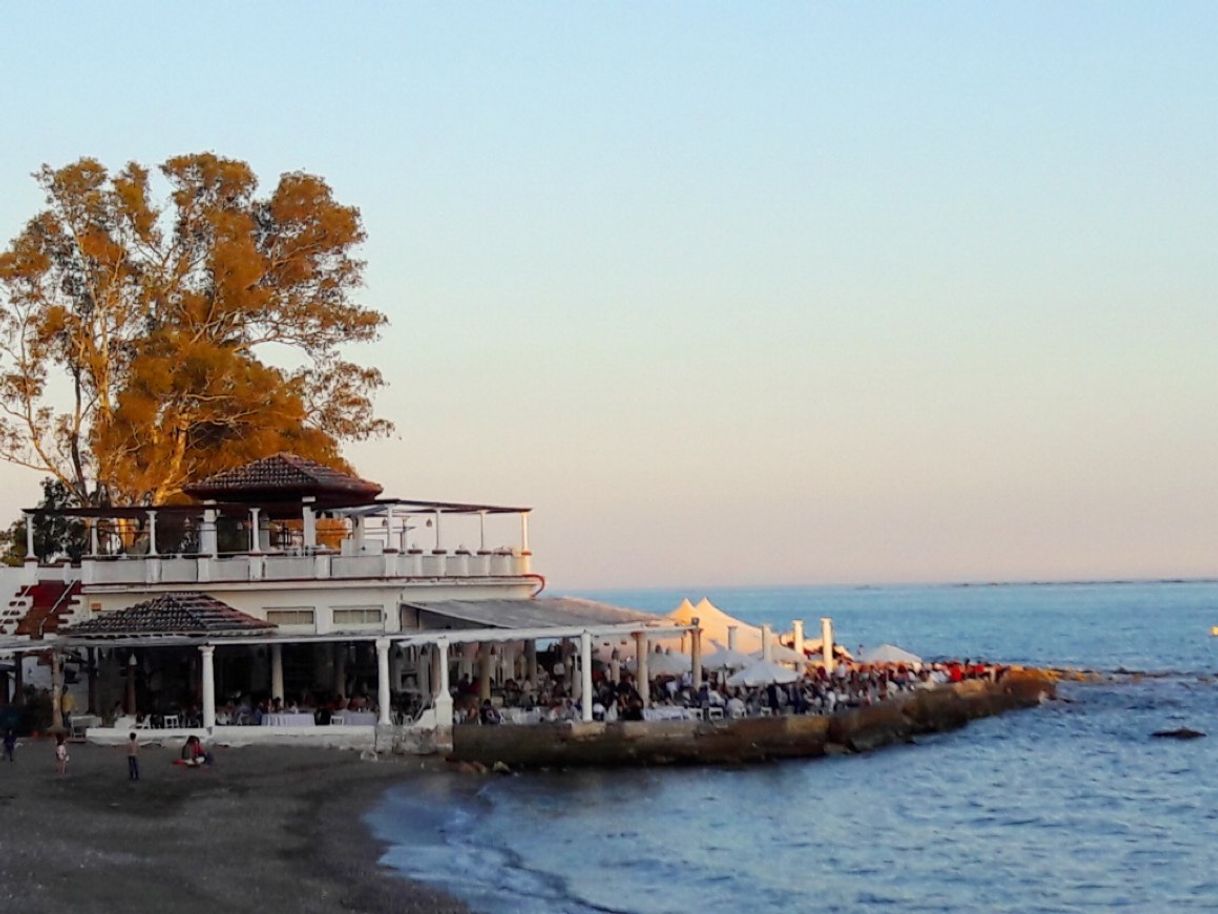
[[448, 669, 1056, 769]]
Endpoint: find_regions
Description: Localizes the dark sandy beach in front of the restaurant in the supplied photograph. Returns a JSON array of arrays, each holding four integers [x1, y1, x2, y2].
[[0, 739, 466, 914]]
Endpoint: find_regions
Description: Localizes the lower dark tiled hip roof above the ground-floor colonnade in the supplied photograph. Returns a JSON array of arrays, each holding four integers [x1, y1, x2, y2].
[[60, 591, 276, 637]]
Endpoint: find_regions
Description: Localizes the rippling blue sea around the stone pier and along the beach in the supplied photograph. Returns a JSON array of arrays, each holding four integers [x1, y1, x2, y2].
[[367, 581, 1218, 914]]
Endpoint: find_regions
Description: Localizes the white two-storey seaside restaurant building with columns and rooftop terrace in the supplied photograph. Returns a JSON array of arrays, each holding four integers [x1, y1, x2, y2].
[[0, 453, 689, 746]]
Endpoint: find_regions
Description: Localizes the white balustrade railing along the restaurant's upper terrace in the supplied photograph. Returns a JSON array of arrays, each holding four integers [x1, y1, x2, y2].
[[79, 550, 531, 585]]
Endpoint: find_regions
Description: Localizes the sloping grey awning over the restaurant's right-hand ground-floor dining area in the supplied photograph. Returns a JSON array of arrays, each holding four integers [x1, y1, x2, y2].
[[403, 597, 671, 629]]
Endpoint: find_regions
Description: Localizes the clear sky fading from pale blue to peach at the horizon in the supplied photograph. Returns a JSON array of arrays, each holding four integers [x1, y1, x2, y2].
[[0, 1, 1218, 589]]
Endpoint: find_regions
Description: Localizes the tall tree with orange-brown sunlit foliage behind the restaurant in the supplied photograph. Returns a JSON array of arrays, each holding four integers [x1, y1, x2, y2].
[[0, 152, 391, 506]]
